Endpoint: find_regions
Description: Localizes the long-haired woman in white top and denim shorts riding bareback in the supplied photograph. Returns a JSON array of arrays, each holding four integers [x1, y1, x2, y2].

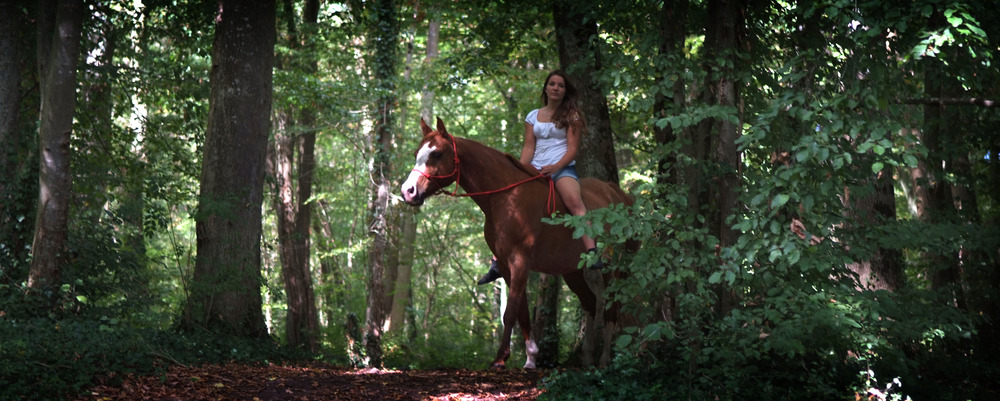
[[478, 70, 603, 285]]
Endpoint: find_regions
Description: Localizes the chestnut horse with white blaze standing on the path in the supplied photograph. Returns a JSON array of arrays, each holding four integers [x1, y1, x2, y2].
[[401, 118, 632, 368]]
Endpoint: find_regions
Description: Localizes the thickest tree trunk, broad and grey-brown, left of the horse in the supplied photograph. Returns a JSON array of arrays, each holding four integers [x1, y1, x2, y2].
[[182, 0, 275, 337]]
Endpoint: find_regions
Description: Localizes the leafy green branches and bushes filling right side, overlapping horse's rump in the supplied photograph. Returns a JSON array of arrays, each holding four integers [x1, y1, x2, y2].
[[545, 1, 1000, 400]]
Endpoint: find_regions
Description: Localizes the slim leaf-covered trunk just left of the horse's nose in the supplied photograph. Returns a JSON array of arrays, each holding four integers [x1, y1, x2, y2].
[[364, 0, 399, 367]]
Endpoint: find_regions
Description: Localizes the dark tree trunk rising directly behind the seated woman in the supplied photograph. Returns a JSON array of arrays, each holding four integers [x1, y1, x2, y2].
[[552, 0, 618, 183]]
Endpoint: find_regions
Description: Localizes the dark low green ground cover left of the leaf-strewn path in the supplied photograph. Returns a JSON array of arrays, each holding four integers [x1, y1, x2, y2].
[[0, 313, 311, 400]]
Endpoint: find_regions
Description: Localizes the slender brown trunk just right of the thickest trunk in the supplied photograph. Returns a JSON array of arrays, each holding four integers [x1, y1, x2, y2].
[[267, 0, 319, 351]]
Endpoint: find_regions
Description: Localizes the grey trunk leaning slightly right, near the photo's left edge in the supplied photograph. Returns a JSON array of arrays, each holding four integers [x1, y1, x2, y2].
[[28, 0, 85, 288]]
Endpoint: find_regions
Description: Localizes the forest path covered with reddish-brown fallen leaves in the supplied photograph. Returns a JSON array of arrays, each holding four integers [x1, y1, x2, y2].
[[78, 363, 546, 401]]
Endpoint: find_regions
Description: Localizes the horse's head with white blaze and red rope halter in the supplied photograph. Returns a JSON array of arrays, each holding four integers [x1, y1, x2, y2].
[[401, 118, 458, 206]]
